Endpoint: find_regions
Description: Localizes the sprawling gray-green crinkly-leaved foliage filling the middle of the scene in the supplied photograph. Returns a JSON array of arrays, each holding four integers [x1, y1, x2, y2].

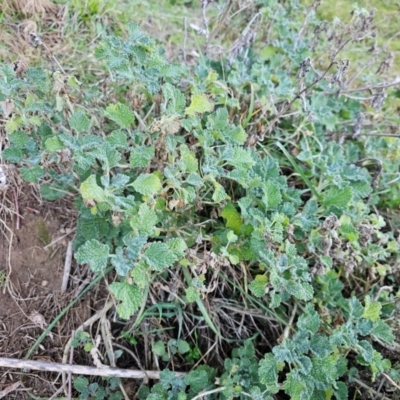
[[0, 1, 399, 400]]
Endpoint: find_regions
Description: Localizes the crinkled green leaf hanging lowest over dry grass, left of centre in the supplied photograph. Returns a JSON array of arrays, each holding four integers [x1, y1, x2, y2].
[[109, 281, 143, 319]]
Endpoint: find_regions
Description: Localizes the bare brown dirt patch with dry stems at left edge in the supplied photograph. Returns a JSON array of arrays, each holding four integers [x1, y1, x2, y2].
[[0, 186, 91, 400]]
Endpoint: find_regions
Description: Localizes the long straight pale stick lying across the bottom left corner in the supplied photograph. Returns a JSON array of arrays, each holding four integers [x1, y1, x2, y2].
[[0, 357, 187, 379]]
